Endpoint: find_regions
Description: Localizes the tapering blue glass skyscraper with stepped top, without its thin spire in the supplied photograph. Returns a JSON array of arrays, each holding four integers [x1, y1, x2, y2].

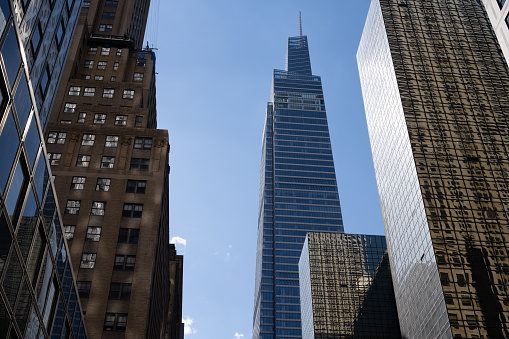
[[253, 28, 343, 339]]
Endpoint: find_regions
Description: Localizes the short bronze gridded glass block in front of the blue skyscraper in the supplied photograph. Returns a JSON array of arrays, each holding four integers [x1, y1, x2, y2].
[[299, 232, 401, 339]]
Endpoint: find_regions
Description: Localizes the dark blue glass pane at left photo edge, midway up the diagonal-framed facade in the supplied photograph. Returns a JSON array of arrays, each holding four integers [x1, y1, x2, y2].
[[0, 111, 19, 189]]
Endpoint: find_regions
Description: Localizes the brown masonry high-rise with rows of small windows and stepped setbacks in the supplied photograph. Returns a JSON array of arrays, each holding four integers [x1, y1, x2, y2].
[[46, 0, 178, 339]]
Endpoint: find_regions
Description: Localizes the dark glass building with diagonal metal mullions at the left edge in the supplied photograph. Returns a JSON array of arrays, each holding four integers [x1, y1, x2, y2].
[[0, 0, 87, 339]]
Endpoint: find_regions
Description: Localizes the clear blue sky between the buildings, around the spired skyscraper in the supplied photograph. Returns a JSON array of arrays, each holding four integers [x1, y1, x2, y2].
[[145, 0, 376, 339]]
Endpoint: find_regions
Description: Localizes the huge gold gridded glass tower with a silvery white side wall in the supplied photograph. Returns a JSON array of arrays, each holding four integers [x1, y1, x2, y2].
[[357, 0, 509, 338]]
